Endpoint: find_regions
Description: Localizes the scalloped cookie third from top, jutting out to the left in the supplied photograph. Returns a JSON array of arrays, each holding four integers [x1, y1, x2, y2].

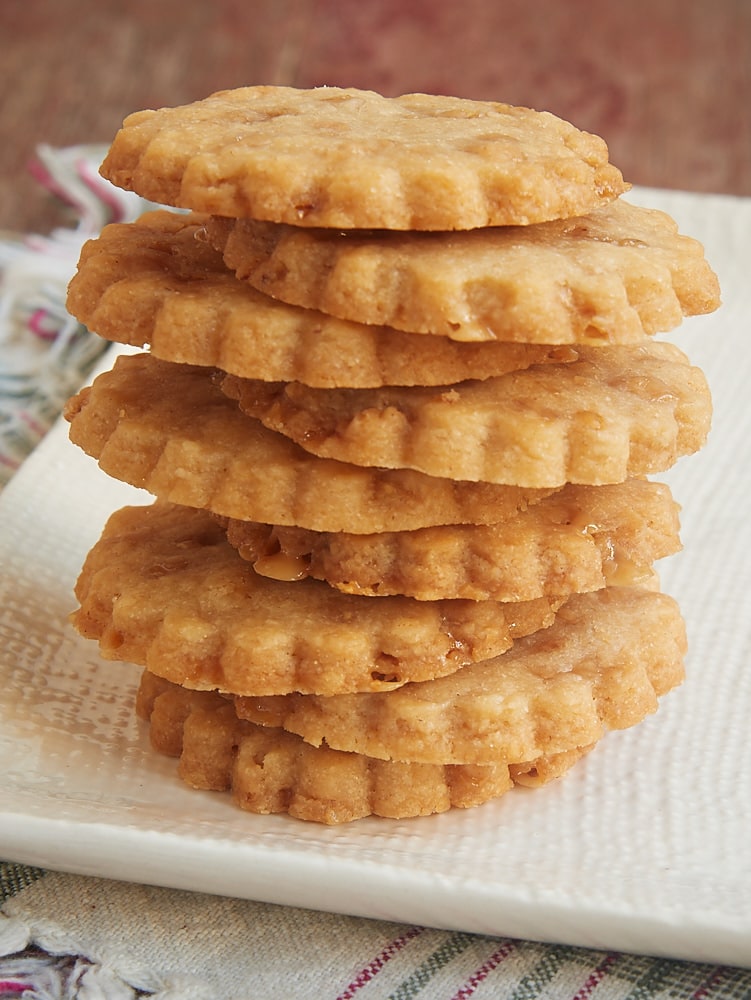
[[67, 211, 568, 388]]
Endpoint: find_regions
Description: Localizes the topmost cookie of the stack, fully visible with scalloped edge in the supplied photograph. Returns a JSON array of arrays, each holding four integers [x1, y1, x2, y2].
[[101, 86, 627, 230]]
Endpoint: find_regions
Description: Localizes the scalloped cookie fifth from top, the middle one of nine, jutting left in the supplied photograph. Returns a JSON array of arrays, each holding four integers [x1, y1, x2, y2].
[[65, 354, 548, 534]]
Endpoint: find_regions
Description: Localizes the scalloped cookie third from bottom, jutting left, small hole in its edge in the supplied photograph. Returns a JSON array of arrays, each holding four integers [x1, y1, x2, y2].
[[72, 501, 561, 695]]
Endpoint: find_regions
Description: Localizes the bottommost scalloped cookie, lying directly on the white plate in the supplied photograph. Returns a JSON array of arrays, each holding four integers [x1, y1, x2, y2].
[[136, 671, 592, 825]]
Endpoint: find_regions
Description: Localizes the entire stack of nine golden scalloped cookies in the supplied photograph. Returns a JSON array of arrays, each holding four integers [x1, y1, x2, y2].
[[61, 87, 719, 823]]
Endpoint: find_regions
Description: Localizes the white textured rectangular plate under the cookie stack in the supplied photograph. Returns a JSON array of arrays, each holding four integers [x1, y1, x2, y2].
[[0, 191, 751, 965]]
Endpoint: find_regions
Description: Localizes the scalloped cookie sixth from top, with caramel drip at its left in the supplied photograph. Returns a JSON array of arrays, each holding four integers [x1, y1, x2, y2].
[[226, 479, 680, 601]]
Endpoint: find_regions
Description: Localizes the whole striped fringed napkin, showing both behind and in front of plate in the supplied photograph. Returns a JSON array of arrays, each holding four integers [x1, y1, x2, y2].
[[0, 147, 751, 1000]]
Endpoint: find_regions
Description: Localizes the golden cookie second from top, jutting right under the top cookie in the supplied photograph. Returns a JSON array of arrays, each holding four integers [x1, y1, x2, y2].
[[207, 200, 719, 345]]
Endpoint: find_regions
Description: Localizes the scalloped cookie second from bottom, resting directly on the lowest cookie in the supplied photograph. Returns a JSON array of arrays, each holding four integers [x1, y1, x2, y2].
[[235, 587, 686, 764]]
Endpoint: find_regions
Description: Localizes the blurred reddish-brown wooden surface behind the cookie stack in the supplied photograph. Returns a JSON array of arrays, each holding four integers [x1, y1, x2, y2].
[[0, 0, 751, 232]]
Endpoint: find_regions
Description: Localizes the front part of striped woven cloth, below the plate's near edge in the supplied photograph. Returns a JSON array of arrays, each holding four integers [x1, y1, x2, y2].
[[0, 862, 751, 1000]]
